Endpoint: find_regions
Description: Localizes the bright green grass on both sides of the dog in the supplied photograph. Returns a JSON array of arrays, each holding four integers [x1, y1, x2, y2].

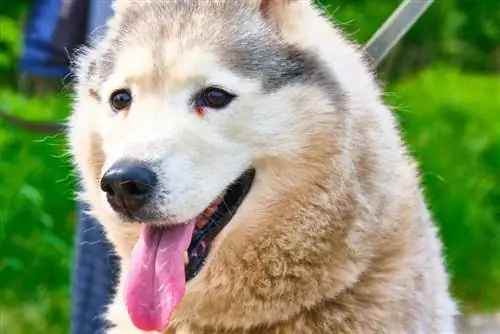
[[0, 69, 500, 334]]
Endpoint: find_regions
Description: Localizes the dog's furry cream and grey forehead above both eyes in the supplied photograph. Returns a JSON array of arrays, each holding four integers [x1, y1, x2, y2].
[[90, 0, 340, 95]]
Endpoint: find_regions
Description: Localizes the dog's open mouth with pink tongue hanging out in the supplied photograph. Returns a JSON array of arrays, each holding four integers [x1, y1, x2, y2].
[[124, 168, 255, 332]]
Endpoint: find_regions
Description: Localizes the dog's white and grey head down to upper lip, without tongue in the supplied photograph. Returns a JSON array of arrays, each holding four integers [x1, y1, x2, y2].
[[70, 0, 344, 227]]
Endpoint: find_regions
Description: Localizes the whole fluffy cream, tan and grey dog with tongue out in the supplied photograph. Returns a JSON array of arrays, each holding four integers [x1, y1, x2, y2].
[[69, 0, 456, 334]]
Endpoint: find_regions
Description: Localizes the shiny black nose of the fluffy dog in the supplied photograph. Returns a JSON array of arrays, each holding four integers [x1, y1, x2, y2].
[[101, 161, 156, 215]]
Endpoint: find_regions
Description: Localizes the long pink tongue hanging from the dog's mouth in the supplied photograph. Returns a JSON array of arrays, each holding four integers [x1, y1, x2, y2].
[[125, 220, 195, 332]]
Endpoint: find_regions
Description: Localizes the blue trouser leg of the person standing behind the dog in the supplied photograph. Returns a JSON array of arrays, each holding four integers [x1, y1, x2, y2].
[[71, 0, 119, 334]]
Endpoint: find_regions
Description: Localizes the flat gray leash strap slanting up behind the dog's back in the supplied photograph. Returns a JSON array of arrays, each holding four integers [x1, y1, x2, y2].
[[364, 0, 434, 67]]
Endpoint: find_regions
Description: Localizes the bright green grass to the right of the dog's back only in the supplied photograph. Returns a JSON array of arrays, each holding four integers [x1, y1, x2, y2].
[[389, 68, 500, 310]]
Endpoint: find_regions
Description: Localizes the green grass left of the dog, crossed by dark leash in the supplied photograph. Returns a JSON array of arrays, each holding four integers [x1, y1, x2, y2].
[[0, 91, 75, 334]]
